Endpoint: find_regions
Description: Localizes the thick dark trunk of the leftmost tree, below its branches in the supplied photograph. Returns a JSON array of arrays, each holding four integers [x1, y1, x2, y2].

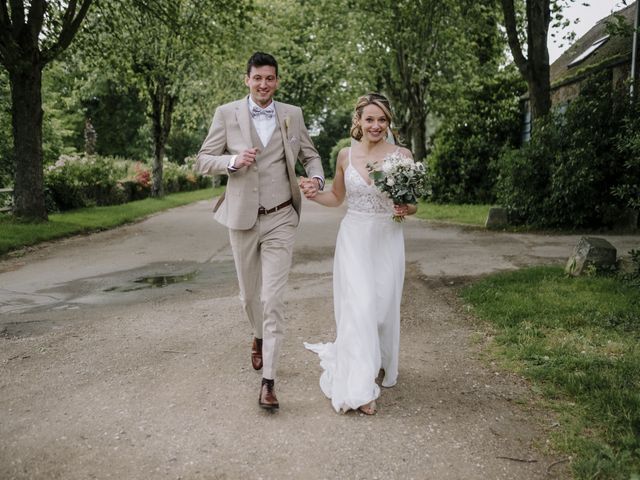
[[9, 63, 47, 220]]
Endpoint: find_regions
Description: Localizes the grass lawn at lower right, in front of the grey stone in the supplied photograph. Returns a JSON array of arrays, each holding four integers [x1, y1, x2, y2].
[[462, 267, 640, 480]]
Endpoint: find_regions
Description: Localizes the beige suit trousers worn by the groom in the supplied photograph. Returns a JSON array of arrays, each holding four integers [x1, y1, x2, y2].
[[229, 206, 298, 379]]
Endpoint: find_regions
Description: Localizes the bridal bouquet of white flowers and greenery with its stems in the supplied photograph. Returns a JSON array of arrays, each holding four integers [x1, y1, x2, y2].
[[367, 152, 428, 222]]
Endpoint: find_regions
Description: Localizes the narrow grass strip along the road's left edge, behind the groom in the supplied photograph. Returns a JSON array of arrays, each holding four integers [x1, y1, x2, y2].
[[0, 188, 223, 255]]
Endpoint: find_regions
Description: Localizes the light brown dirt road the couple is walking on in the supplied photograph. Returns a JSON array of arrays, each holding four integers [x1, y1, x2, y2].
[[0, 198, 640, 480]]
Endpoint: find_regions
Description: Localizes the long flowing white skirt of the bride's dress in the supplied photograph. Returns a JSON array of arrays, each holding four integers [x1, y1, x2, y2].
[[305, 210, 405, 412]]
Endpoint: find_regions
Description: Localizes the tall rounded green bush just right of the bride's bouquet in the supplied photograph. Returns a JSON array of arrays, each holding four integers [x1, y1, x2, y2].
[[427, 65, 523, 204]]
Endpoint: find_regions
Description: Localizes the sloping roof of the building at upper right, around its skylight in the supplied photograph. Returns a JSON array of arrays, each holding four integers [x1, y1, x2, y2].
[[550, 1, 638, 87]]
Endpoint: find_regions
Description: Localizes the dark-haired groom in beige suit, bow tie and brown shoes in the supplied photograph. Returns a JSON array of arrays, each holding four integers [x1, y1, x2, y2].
[[196, 52, 324, 410]]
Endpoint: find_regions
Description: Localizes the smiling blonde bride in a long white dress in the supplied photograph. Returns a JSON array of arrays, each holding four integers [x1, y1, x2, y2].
[[301, 94, 416, 415]]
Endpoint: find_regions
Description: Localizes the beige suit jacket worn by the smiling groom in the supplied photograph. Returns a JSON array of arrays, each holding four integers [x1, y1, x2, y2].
[[195, 97, 324, 230]]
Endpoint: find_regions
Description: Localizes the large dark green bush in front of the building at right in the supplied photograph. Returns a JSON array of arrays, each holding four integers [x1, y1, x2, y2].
[[497, 75, 631, 228]]
